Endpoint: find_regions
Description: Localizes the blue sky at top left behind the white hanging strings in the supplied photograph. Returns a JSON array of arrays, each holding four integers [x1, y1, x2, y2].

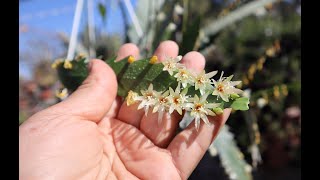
[[19, 0, 135, 78]]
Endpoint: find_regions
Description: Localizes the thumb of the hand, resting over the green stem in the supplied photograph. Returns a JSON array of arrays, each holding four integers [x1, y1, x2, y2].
[[55, 59, 117, 122]]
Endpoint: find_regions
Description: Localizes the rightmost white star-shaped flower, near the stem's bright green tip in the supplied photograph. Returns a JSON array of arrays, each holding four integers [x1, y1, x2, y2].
[[212, 71, 243, 102]]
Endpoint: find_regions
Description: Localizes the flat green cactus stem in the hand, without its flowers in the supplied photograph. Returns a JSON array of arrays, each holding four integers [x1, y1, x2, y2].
[[57, 56, 249, 113]]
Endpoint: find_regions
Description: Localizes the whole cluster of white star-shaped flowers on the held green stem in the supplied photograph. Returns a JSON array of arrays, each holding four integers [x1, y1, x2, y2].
[[127, 56, 242, 130]]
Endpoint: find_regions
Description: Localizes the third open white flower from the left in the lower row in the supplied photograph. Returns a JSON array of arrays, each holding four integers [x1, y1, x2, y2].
[[168, 83, 188, 115]]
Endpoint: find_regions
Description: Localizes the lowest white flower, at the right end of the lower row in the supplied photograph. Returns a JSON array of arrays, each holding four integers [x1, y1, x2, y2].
[[186, 93, 220, 130]]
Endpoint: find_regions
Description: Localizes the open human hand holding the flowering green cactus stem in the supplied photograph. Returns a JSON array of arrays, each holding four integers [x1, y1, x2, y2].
[[19, 41, 230, 180]]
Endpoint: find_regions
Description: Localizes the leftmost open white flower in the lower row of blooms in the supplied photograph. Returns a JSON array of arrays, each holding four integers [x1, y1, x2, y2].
[[134, 84, 157, 116]]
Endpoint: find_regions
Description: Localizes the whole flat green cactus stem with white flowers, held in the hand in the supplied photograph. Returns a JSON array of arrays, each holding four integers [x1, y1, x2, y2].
[[52, 56, 249, 130]]
